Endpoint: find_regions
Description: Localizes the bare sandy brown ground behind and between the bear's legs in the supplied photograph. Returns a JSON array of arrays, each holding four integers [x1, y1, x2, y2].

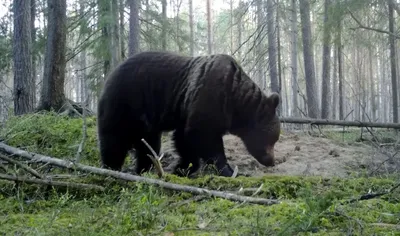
[[157, 130, 400, 177]]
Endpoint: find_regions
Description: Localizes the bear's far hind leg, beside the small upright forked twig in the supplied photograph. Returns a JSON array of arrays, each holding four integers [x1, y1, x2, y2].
[[134, 133, 161, 174]]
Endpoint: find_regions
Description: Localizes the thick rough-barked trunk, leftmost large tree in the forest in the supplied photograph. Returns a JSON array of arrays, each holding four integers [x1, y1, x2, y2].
[[13, 0, 35, 115]]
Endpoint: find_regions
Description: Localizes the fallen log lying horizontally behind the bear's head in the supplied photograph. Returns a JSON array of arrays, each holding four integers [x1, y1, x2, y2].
[[279, 117, 400, 129]]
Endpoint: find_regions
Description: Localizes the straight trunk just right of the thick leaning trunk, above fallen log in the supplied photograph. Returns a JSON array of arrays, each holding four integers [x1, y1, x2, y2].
[[321, 0, 331, 119]]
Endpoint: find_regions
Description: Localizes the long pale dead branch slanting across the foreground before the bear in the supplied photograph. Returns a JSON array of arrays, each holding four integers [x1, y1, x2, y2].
[[0, 142, 280, 205]]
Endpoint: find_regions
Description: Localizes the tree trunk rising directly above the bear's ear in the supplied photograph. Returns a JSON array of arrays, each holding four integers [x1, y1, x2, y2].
[[267, 0, 280, 93]]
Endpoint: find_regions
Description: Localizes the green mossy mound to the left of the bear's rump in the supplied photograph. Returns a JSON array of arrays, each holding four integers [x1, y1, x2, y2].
[[0, 112, 98, 163]]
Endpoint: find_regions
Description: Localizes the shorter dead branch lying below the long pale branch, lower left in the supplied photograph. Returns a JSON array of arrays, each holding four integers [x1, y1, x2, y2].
[[0, 174, 105, 191]]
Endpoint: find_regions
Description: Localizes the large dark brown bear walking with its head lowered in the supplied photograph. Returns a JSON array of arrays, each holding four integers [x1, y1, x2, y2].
[[97, 52, 280, 176]]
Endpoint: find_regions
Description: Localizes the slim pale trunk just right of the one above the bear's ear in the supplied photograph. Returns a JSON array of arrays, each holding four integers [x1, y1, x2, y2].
[[290, 0, 299, 117]]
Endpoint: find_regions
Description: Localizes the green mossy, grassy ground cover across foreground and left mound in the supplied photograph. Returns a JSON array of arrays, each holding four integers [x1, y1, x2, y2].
[[0, 114, 400, 235]]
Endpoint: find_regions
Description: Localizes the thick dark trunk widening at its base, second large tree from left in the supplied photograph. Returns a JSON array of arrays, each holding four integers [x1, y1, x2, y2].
[[38, 0, 67, 111]]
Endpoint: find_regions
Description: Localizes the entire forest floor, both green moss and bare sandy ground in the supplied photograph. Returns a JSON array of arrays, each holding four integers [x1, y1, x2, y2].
[[0, 113, 400, 236]]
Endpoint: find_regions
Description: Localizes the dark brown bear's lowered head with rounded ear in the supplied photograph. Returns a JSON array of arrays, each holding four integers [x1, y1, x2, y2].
[[241, 93, 281, 166]]
